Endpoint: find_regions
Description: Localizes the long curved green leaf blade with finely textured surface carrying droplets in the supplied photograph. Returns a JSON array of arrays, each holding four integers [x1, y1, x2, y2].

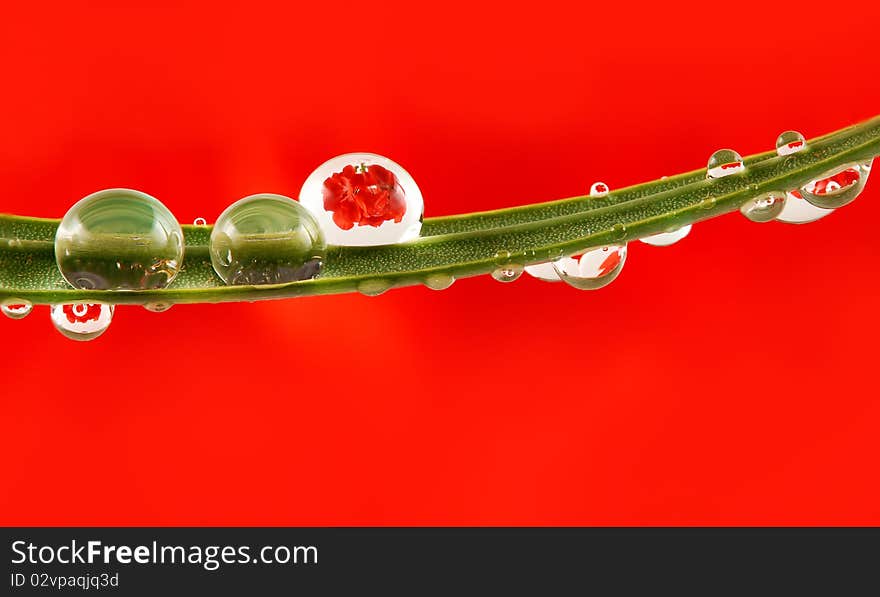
[[0, 117, 880, 304]]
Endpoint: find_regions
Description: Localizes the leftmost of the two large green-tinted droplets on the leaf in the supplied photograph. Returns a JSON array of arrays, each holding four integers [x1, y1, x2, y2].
[[55, 189, 183, 290]]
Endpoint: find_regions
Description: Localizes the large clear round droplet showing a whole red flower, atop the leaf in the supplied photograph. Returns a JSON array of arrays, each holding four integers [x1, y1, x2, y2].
[[299, 153, 424, 247]]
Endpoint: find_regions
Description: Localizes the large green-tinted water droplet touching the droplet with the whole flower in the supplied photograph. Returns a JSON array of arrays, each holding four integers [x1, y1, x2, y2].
[[211, 193, 326, 285]]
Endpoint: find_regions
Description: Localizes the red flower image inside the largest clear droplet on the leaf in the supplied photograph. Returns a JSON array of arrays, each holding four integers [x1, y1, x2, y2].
[[322, 164, 406, 230]]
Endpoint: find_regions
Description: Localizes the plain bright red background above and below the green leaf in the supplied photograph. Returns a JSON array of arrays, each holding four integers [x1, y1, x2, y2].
[[0, 0, 880, 525]]
